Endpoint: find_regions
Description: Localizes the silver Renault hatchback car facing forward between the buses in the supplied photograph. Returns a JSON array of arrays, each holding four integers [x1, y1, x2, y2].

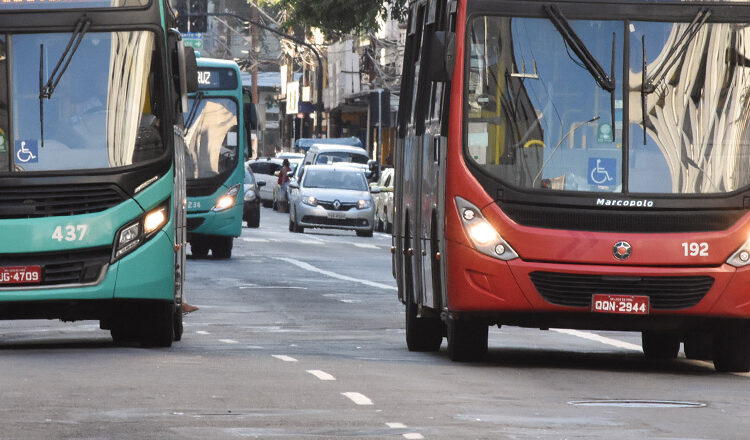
[[289, 165, 377, 237]]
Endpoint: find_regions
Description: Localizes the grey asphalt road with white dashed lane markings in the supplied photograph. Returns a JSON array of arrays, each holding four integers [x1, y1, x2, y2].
[[0, 209, 750, 439]]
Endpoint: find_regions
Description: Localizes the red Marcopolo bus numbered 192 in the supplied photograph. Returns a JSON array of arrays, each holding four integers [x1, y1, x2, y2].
[[393, 0, 750, 371]]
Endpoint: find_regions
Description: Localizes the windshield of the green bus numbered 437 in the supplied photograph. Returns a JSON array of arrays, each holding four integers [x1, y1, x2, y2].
[[0, 31, 165, 172]]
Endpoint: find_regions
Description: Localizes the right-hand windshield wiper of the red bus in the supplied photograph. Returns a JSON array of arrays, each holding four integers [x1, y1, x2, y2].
[[641, 9, 711, 145]]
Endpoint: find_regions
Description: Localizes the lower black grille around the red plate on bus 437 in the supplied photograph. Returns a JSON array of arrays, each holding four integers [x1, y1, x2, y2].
[[0, 247, 112, 290]]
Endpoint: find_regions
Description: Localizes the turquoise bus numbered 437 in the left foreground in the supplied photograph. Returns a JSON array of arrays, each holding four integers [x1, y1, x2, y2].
[[0, 0, 197, 346]]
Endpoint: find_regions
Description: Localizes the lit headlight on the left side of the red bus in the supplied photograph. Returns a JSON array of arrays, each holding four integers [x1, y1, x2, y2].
[[456, 197, 518, 261]]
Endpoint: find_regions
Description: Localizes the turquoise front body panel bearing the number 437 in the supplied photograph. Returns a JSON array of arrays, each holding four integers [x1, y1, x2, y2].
[[0, 171, 175, 302]]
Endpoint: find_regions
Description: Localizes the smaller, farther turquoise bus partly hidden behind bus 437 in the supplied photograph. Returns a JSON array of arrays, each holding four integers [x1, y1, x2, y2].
[[185, 57, 250, 258]]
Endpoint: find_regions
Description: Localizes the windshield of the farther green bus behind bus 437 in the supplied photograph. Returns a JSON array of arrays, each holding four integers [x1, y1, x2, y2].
[[185, 96, 239, 180]]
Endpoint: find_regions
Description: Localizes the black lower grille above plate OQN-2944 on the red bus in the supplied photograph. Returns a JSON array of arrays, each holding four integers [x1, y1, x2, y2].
[[529, 272, 714, 310]]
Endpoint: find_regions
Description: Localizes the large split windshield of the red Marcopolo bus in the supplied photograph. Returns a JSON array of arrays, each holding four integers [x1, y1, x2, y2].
[[465, 14, 750, 194]]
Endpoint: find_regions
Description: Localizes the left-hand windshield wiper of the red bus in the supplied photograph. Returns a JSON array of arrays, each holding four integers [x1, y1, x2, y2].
[[544, 5, 616, 129]]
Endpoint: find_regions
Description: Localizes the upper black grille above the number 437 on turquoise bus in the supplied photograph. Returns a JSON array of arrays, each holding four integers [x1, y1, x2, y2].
[[0, 185, 125, 219]]
